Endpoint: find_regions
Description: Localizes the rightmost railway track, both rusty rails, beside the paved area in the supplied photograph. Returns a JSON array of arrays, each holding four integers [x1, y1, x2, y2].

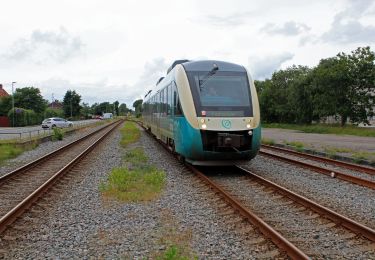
[[259, 145, 375, 189]]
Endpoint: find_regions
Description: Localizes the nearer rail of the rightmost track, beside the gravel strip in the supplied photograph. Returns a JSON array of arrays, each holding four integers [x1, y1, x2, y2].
[[259, 151, 375, 189]]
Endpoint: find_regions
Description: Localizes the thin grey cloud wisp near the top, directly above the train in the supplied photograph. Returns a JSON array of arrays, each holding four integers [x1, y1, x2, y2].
[[193, 12, 252, 27]]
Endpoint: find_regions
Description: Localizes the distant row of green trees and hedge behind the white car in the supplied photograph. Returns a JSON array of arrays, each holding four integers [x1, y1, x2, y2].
[[0, 87, 131, 126]]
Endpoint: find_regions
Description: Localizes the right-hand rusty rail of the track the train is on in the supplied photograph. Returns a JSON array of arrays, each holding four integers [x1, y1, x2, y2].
[[236, 166, 375, 242]]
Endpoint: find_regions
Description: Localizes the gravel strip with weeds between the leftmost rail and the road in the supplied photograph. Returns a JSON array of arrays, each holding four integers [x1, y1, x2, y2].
[[0, 123, 108, 176]]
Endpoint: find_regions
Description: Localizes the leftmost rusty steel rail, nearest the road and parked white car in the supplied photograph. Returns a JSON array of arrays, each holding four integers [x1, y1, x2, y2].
[[0, 121, 118, 184]]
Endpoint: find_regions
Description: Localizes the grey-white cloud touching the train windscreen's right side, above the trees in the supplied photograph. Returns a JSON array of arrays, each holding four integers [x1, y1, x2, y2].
[[249, 52, 294, 80]]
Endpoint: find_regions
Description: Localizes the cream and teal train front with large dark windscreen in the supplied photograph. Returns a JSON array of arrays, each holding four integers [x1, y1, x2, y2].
[[175, 61, 261, 165]]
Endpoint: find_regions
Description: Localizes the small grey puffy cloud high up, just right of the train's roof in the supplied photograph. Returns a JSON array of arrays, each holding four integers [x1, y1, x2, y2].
[[260, 21, 311, 36]]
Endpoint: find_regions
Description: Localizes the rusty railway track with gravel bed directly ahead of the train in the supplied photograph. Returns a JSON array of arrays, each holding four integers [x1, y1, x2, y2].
[[188, 165, 375, 259]]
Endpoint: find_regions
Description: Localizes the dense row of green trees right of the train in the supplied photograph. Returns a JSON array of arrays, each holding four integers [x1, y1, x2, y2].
[[255, 47, 375, 126]]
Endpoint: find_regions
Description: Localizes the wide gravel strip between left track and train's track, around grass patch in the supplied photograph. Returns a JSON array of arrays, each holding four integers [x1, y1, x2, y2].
[[0, 125, 280, 259]]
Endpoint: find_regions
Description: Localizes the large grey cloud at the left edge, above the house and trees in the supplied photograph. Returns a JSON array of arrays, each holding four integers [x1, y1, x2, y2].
[[0, 27, 84, 64]]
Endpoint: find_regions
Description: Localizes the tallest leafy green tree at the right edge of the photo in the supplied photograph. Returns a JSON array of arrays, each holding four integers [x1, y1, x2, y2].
[[313, 47, 375, 126]]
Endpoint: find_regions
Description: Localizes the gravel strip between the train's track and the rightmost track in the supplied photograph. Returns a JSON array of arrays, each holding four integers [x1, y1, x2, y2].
[[246, 156, 375, 228]]
